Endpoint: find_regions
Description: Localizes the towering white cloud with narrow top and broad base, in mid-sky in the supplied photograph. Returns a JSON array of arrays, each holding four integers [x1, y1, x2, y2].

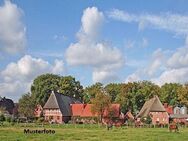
[[65, 7, 124, 82]]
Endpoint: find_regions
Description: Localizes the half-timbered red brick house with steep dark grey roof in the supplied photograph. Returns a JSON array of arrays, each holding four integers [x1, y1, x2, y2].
[[43, 92, 81, 123]]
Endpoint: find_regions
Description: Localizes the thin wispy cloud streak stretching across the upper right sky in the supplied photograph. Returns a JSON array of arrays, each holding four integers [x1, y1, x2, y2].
[[108, 9, 188, 35]]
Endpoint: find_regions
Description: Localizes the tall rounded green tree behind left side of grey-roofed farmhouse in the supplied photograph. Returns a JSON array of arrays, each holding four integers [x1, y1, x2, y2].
[[31, 74, 61, 106]]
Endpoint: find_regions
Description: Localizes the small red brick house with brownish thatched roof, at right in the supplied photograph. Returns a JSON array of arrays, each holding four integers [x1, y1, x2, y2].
[[136, 96, 169, 125]]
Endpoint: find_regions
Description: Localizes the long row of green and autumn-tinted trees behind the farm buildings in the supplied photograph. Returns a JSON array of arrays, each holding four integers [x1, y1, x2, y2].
[[19, 74, 188, 116]]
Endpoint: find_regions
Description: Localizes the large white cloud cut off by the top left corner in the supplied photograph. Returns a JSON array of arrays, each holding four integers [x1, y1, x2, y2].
[[0, 0, 26, 54]]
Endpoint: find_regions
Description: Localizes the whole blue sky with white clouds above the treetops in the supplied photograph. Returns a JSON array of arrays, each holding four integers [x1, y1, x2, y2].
[[0, 0, 188, 101]]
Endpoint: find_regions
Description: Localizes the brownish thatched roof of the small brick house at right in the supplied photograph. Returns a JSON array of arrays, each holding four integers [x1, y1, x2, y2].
[[136, 95, 166, 117]]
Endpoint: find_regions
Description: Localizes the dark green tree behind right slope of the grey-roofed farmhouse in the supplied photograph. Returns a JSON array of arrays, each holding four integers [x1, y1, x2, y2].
[[59, 76, 84, 100]]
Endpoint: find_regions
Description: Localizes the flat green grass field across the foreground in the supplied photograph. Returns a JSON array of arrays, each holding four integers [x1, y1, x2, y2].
[[0, 125, 188, 141]]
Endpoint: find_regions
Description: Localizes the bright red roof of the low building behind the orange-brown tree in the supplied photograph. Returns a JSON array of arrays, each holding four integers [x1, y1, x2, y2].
[[71, 104, 120, 117]]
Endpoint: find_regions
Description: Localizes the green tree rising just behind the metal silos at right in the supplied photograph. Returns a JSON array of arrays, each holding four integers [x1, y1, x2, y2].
[[161, 83, 182, 105]]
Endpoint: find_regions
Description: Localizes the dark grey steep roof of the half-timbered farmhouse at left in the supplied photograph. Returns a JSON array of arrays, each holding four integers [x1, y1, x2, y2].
[[43, 92, 81, 116]]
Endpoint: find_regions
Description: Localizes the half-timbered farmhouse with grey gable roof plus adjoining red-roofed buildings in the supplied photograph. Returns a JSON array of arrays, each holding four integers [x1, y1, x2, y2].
[[42, 92, 120, 123]]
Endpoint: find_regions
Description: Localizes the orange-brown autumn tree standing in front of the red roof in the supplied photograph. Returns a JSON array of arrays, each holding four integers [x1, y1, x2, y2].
[[91, 90, 111, 123]]
